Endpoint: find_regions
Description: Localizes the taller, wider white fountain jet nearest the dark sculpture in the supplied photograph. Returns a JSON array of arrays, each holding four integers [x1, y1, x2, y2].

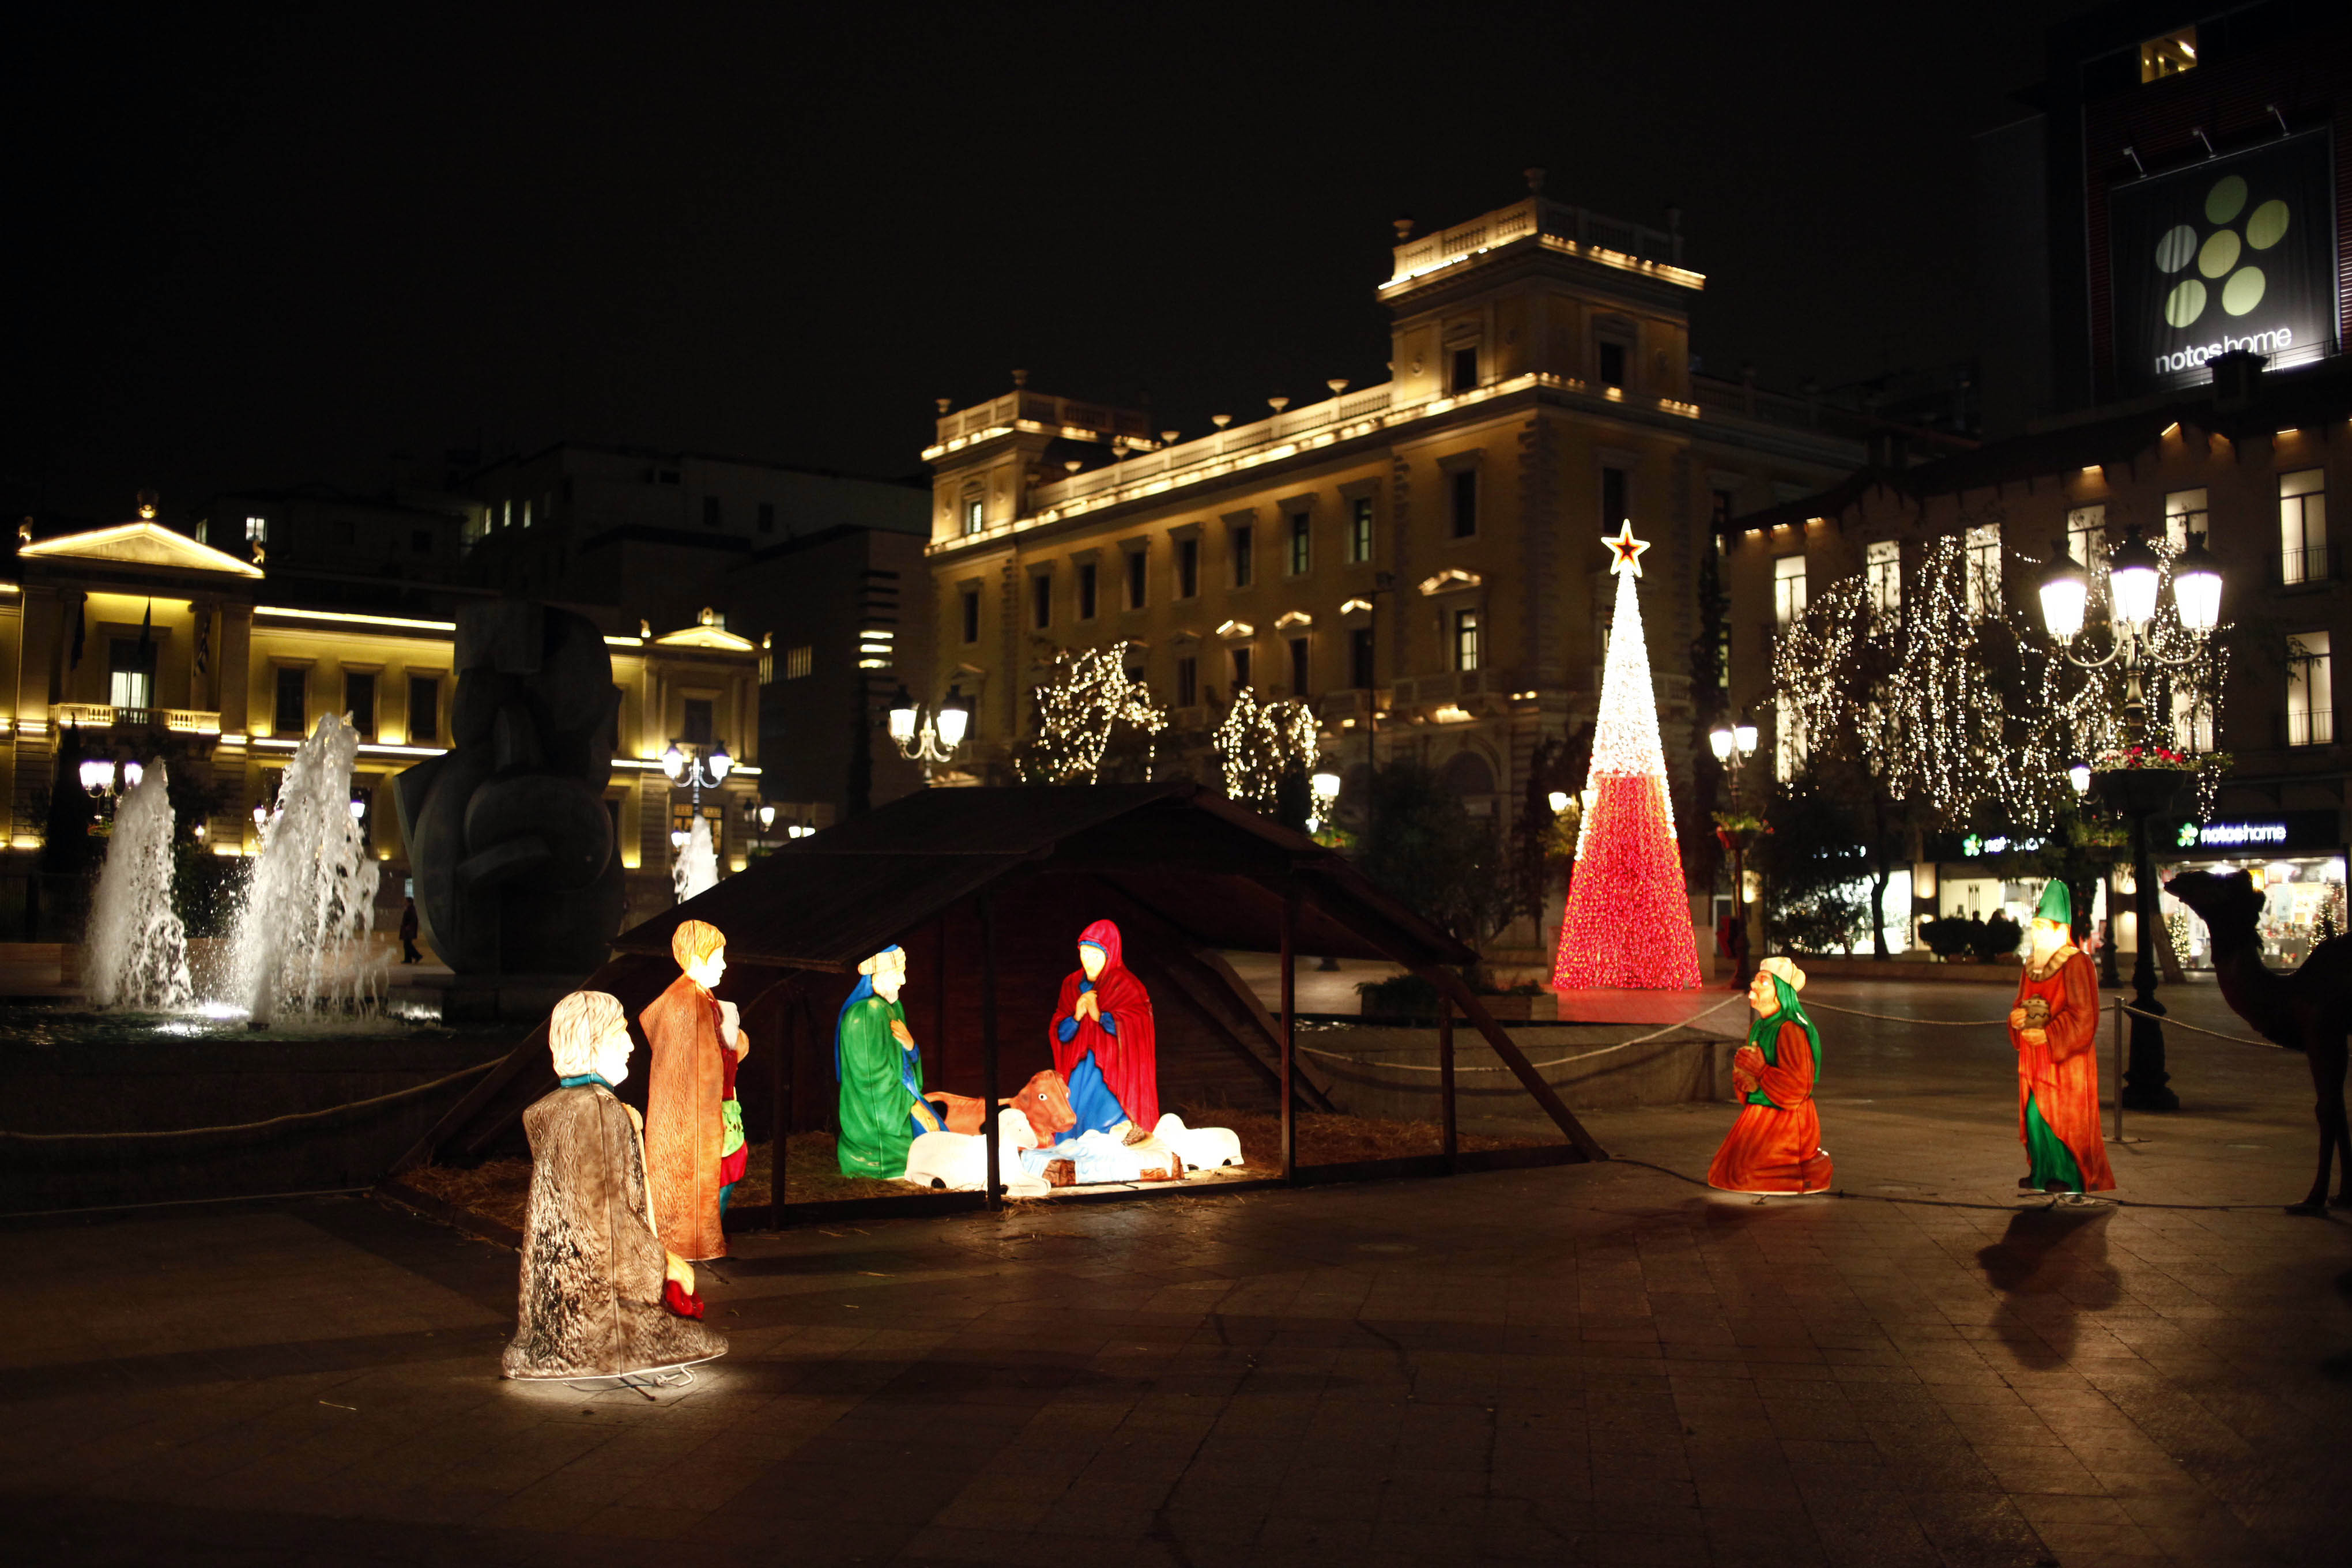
[[224, 715, 383, 1027]]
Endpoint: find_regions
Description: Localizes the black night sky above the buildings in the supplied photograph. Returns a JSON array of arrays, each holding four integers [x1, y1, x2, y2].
[[0, 0, 2079, 519]]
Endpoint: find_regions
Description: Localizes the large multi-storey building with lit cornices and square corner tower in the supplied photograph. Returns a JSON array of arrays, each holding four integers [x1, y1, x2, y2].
[[917, 172, 1863, 949]]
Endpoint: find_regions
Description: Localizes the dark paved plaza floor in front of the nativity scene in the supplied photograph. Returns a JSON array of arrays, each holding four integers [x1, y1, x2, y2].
[[0, 981, 2352, 1568]]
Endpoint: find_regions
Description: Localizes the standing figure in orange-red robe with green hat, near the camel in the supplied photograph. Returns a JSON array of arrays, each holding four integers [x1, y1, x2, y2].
[[2008, 877, 2114, 1194]]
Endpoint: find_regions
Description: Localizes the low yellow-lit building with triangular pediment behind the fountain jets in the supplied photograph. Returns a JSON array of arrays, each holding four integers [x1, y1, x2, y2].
[[0, 515, 757, 929]]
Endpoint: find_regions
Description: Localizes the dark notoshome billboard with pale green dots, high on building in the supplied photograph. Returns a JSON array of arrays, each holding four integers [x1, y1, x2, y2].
[[2108, 131, 2335, 393]]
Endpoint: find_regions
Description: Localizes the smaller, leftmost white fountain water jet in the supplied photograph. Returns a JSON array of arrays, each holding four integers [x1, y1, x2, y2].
[[82, 762, 195, 1013]]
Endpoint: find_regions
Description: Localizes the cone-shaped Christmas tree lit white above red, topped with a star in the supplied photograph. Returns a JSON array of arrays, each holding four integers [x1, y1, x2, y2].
[[1552, 522, 1698, 990]]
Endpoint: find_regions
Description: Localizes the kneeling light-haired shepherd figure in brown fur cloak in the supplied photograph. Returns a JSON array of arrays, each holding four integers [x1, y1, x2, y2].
[[501, 992, 727, 1378]]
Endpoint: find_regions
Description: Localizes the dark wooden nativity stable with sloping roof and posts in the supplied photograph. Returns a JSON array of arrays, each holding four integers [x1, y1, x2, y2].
[[395, 783, 1607, 1223]]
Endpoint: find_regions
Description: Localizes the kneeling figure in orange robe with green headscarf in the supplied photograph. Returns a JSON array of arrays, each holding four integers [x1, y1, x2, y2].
[[1708, 957, 1830, 1192]]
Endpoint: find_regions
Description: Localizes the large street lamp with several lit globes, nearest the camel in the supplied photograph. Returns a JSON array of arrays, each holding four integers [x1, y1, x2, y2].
[[2041, 529, 2221, 1110]]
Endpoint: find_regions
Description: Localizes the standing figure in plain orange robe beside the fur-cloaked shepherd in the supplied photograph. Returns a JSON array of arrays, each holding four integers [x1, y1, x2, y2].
[[638, 919, 751, 1262]]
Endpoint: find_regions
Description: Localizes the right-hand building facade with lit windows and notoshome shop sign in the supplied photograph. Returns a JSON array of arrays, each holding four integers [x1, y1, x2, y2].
[[1724, 357, 2352, 964]]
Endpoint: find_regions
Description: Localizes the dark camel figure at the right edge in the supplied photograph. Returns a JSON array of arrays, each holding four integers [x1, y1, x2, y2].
[[2164, 872, 2352, 1213]]
